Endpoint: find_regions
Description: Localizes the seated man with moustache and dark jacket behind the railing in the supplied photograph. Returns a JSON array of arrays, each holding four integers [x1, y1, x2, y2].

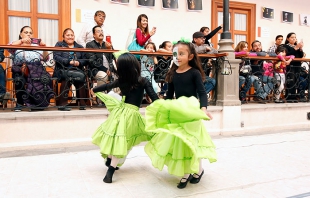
[[85, 25, 113, 86]]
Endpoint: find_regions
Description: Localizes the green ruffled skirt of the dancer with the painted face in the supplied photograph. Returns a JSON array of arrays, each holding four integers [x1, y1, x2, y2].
[[144, 97, 217, 176]]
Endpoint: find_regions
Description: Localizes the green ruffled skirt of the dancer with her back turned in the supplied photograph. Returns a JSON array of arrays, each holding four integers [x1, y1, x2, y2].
[[92, 93, 152, 162]]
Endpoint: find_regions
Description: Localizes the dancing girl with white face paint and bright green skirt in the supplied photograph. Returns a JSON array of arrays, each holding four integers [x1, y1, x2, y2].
[[145, 41, 216, 188]]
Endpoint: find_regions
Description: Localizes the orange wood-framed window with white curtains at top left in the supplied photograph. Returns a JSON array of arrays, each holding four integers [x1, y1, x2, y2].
[[0, 0, 71, 46]]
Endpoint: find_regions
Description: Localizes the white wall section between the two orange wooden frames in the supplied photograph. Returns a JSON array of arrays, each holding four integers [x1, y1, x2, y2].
[[71, 0, 211, 49]]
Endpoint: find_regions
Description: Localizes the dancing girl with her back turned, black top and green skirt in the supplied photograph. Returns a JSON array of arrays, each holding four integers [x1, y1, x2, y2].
[[91, 53, 158, 183]]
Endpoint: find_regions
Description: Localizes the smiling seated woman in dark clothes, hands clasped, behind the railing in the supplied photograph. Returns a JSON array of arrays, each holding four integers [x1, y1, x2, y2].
[[53, 28, 86, 111]]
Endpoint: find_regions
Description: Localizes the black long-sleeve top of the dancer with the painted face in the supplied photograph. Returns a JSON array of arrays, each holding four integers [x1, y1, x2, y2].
[[166, 68, 208, 107]]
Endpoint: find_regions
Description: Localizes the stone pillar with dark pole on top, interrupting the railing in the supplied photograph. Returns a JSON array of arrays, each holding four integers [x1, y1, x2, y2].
[[216, 0, 241, 135]]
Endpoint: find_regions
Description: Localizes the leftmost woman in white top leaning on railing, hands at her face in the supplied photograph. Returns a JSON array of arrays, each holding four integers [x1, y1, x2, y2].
[[8, 26, 49, 111]]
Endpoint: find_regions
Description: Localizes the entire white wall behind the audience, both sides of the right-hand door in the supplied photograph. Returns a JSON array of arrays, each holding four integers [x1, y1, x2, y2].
[[71, 0, 310, 57]]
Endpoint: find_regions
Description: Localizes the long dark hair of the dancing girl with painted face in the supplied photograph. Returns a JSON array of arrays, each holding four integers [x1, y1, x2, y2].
[[165, 41, 206, 82]]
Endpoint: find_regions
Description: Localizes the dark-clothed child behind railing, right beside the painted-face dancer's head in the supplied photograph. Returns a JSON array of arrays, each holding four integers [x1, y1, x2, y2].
[[154, 41, 172, 98]]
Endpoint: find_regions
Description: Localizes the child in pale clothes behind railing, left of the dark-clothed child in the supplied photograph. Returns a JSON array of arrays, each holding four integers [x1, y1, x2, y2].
[[140, 42, 158, 93]]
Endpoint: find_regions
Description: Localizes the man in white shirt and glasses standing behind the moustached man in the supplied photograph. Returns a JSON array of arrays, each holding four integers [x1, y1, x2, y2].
[[76, 10, 111, 48]]
